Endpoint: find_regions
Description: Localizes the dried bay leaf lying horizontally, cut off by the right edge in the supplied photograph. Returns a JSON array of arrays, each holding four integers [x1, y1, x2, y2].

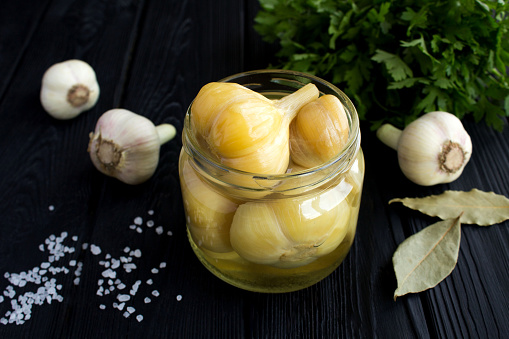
[[389, 189, 509, 226]]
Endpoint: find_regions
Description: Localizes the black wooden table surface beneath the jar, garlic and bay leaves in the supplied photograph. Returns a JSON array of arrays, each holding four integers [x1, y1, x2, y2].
[[0, 0, 509, 338]]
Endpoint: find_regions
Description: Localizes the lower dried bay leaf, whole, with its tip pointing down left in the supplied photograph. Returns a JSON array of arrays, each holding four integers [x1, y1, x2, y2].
[[392, 215, 461, 300]]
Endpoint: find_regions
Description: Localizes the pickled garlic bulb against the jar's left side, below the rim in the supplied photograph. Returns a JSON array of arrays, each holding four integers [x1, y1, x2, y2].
[[180, 155, 238, 253]]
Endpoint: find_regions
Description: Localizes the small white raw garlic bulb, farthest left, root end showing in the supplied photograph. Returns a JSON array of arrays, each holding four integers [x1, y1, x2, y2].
[[40, 60, 100, 120]]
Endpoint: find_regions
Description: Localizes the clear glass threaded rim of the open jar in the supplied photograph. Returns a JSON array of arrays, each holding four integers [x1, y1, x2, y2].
[[182, 69, 361, 191]]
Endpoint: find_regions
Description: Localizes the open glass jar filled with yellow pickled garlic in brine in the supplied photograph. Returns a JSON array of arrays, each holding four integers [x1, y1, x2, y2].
[[179, 70, 364, 293]]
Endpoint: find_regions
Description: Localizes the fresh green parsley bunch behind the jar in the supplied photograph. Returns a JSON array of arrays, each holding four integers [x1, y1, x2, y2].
[[254, 0, 509, 130]]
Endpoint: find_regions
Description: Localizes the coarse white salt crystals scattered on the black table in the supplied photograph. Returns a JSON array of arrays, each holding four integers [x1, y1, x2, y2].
[[0, 210, 168, 325]]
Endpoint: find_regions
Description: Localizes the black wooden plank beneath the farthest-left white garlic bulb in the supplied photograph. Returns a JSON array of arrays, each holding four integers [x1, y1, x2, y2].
[[0, 0, 143, 338]]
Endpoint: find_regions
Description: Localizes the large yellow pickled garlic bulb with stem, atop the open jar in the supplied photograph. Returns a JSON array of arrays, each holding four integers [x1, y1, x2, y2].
[[191, 82, 319, 174]]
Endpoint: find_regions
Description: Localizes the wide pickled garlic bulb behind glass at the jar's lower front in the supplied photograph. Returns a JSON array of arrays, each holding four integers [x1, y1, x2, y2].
[[230, 181, 352, 268]]
